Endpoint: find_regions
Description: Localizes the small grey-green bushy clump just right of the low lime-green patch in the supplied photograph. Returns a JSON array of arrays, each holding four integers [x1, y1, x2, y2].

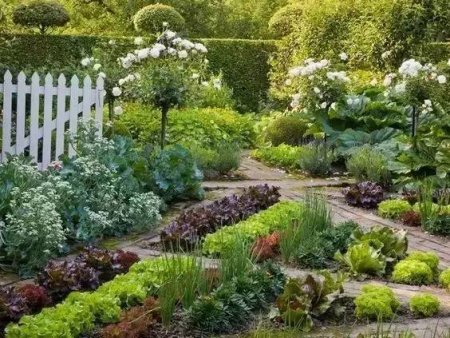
[[299, 143, 334, 177]]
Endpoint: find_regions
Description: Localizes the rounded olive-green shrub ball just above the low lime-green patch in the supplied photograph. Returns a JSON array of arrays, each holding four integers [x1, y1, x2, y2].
[[264, 115, 308, 147]]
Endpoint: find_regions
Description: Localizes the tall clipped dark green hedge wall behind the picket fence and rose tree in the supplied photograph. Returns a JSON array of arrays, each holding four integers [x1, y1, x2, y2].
[[0, 34, 276, 111]]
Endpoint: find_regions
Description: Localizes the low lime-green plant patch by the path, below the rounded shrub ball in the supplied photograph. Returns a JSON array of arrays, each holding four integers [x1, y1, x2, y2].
[[252, 144, 304, 170]]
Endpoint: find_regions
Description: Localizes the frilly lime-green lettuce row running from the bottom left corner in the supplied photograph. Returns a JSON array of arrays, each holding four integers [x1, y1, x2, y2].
[[5, 257, 195, 338]]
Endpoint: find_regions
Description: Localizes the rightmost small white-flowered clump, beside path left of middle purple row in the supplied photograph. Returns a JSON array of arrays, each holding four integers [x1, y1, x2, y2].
[[125, 192, 163, 231]]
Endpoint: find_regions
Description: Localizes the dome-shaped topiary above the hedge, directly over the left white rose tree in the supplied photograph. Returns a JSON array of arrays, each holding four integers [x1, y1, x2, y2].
[[133, 4, 185, 34]]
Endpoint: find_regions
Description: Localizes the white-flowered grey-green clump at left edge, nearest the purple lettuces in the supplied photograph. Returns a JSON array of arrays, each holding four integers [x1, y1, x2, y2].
[[1, 182, 66, 275]]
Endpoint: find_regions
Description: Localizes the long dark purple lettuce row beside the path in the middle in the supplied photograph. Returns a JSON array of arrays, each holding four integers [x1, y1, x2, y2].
[[161, 185, 280, 249]]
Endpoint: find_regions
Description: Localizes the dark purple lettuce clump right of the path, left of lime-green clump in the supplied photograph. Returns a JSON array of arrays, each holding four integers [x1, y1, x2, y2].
[[342, 181, 384, 209]]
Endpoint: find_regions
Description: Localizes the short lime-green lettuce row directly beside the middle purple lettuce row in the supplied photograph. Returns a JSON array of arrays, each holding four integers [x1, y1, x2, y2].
[[202, 201, 303, 255]]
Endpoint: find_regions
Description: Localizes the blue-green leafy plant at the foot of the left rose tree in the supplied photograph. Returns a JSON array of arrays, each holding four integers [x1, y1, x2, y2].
[[151, 145, 204, 201]]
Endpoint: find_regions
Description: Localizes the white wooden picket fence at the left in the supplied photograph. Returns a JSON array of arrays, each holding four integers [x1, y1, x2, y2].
[[0, 71, 104, 170]]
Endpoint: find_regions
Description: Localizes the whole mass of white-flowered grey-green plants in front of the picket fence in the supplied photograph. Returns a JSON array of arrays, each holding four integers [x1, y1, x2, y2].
[[0, 126, 163, 275]]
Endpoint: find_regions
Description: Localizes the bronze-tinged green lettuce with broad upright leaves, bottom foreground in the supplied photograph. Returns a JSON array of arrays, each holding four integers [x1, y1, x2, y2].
[[277, 270, 345, 332]]
